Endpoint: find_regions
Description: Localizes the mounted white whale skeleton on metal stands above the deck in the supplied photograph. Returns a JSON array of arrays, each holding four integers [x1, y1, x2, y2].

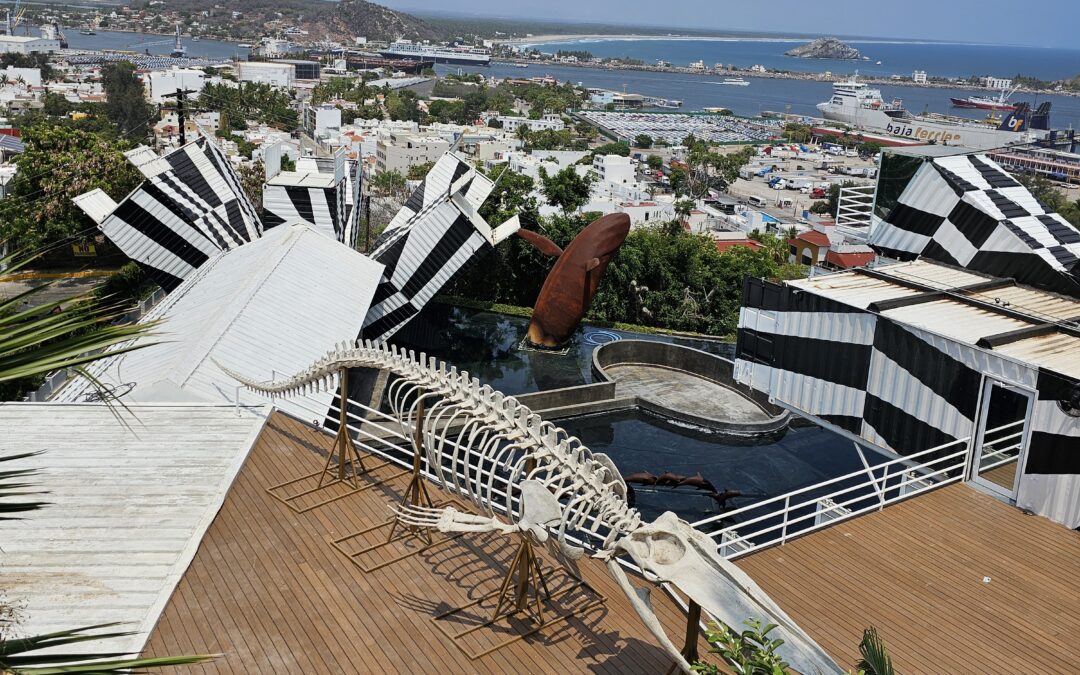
[[219, 340, 843, 675]]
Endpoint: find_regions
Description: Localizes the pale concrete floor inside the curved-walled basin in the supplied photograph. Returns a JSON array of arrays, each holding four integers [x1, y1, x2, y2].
[[605, 364, 770, 423]]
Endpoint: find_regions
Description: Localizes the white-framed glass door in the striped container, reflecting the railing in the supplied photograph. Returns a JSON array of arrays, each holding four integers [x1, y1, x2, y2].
[[970, 379, 1034, 499]]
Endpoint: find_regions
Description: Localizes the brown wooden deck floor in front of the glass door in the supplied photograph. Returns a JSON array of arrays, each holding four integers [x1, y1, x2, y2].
[[738, 484, 1080, 675]]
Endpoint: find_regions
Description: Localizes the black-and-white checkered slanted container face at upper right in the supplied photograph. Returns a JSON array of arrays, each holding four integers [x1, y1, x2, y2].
[[869, 154, 1080, 296]]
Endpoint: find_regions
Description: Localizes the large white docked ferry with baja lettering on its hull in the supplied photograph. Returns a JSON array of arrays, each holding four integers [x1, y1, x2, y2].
[[818, 78, 1050, 149]]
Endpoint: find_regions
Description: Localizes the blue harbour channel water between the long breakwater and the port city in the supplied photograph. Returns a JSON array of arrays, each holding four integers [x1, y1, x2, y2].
[[436, 65, 1080, 129]]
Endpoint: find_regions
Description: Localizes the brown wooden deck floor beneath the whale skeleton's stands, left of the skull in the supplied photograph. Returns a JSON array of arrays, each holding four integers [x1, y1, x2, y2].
[[144, 415, 721, 674]]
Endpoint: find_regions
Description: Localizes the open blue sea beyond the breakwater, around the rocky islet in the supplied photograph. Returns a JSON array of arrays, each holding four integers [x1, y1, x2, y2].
[[531, 38, 1080, 80]]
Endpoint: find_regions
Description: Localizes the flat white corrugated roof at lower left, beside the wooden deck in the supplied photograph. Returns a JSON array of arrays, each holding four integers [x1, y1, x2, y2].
[[0, 403, 265, 653]]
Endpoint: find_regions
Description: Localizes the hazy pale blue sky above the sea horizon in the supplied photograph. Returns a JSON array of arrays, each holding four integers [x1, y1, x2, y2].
[[384, 0, 1080, 50]]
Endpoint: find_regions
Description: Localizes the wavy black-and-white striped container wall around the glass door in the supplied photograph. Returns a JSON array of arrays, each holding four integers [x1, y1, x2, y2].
[[734, 279, 1080, 528]]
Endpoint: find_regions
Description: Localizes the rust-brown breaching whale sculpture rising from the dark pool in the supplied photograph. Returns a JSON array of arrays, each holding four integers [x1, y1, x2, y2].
[[517, 213, 630, 349]]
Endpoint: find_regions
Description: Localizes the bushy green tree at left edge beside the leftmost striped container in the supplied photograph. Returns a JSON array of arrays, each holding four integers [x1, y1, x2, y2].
[[0, 125, 141, 251]]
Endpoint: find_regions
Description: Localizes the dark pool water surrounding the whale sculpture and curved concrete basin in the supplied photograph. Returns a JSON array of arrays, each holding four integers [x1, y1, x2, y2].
[[394, 303, 882, 522]]
